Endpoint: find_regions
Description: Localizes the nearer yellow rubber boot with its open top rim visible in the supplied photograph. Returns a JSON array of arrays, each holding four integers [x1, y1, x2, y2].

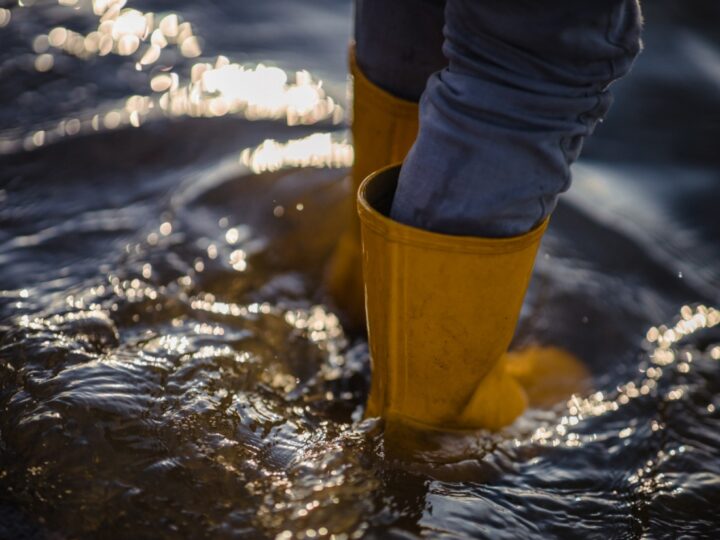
[[358, 166, 586, 430]]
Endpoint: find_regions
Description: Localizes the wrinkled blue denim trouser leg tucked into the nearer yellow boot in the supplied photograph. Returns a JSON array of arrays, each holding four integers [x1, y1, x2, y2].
[[356, 0, 641, 236]]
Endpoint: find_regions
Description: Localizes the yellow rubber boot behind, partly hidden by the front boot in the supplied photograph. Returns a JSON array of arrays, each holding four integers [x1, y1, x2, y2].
[[326, 49, 418, 326]]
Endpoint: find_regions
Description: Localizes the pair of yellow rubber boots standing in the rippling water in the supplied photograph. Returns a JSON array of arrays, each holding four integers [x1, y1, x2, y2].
[[327, 49, 586, 430]]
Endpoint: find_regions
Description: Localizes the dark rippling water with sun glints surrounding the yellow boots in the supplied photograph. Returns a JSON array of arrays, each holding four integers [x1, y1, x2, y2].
[[0, 0, 720, 538]]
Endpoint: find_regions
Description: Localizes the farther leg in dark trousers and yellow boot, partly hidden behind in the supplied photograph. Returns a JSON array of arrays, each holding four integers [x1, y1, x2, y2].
[[325, 0, 446, 327]]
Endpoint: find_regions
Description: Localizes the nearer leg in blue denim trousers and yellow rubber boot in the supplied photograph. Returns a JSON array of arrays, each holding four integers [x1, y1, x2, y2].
[[358, 0, 640, 429]]
